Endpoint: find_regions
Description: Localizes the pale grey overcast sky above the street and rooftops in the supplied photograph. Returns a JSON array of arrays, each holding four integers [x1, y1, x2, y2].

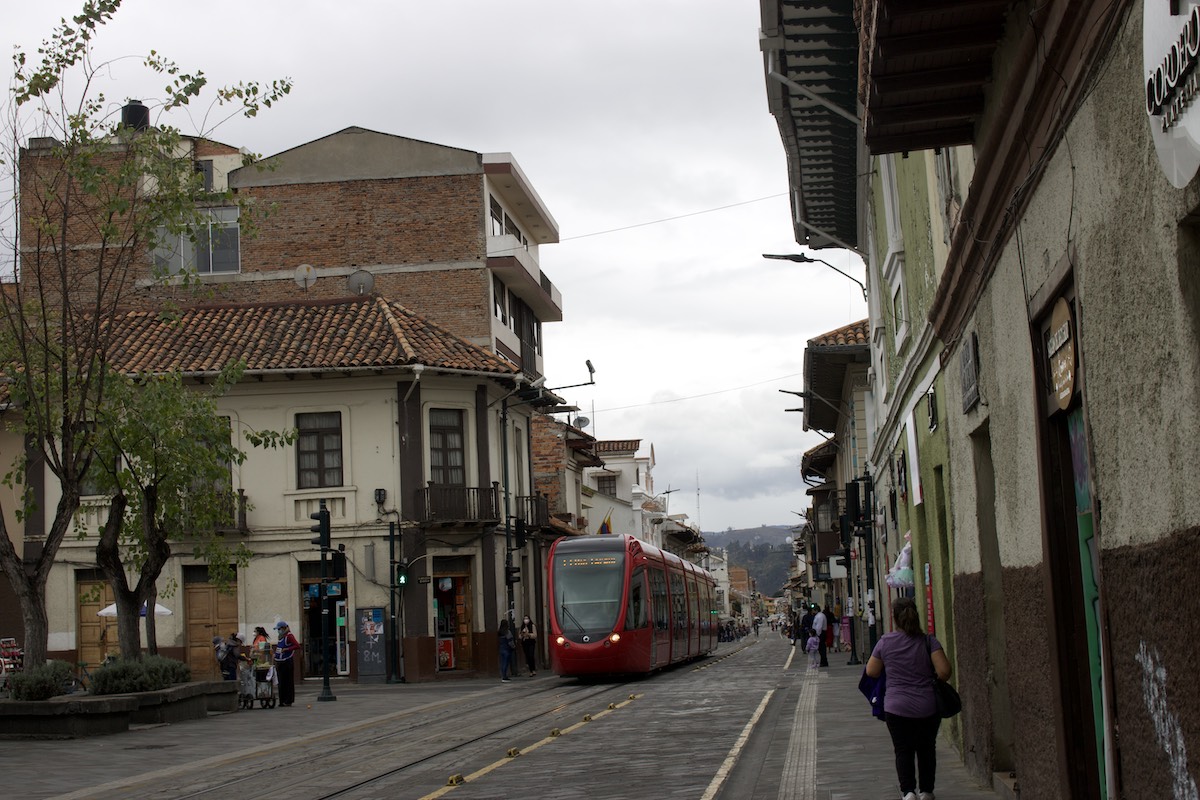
[[0, 0, 866, 530]]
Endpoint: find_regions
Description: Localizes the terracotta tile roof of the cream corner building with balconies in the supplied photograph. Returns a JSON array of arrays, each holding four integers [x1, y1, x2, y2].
[[109, 296, 517, 374]]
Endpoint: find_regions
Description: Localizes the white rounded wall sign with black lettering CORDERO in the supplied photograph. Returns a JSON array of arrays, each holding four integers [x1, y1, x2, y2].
[[1141, 0, 1200, 188]]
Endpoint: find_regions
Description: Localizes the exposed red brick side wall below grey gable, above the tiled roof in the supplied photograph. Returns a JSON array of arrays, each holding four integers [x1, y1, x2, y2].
[[138, 175, 492, 341]]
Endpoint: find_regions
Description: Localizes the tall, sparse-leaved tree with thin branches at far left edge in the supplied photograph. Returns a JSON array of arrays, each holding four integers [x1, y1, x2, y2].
[[0, 0, 290, 664]]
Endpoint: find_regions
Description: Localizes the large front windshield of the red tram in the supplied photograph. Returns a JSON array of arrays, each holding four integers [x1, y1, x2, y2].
[[554, 552, 625, 633]]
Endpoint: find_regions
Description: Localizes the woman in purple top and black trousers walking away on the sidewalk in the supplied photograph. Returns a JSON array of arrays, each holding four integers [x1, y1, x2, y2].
[[866, 597, 952, 800]]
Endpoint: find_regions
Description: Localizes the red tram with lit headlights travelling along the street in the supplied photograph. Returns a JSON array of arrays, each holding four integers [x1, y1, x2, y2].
[[547, 534, 718, 675]]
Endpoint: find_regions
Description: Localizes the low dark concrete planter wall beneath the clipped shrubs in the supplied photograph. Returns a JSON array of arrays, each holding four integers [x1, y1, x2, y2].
[[0, 680, 238, 739]]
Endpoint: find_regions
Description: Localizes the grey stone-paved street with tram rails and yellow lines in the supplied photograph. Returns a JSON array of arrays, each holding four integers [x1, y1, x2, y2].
[[0, 632, 996, 800]]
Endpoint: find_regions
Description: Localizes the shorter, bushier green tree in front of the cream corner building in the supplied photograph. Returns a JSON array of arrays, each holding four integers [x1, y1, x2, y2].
[[83, 363, 292, 660]]
